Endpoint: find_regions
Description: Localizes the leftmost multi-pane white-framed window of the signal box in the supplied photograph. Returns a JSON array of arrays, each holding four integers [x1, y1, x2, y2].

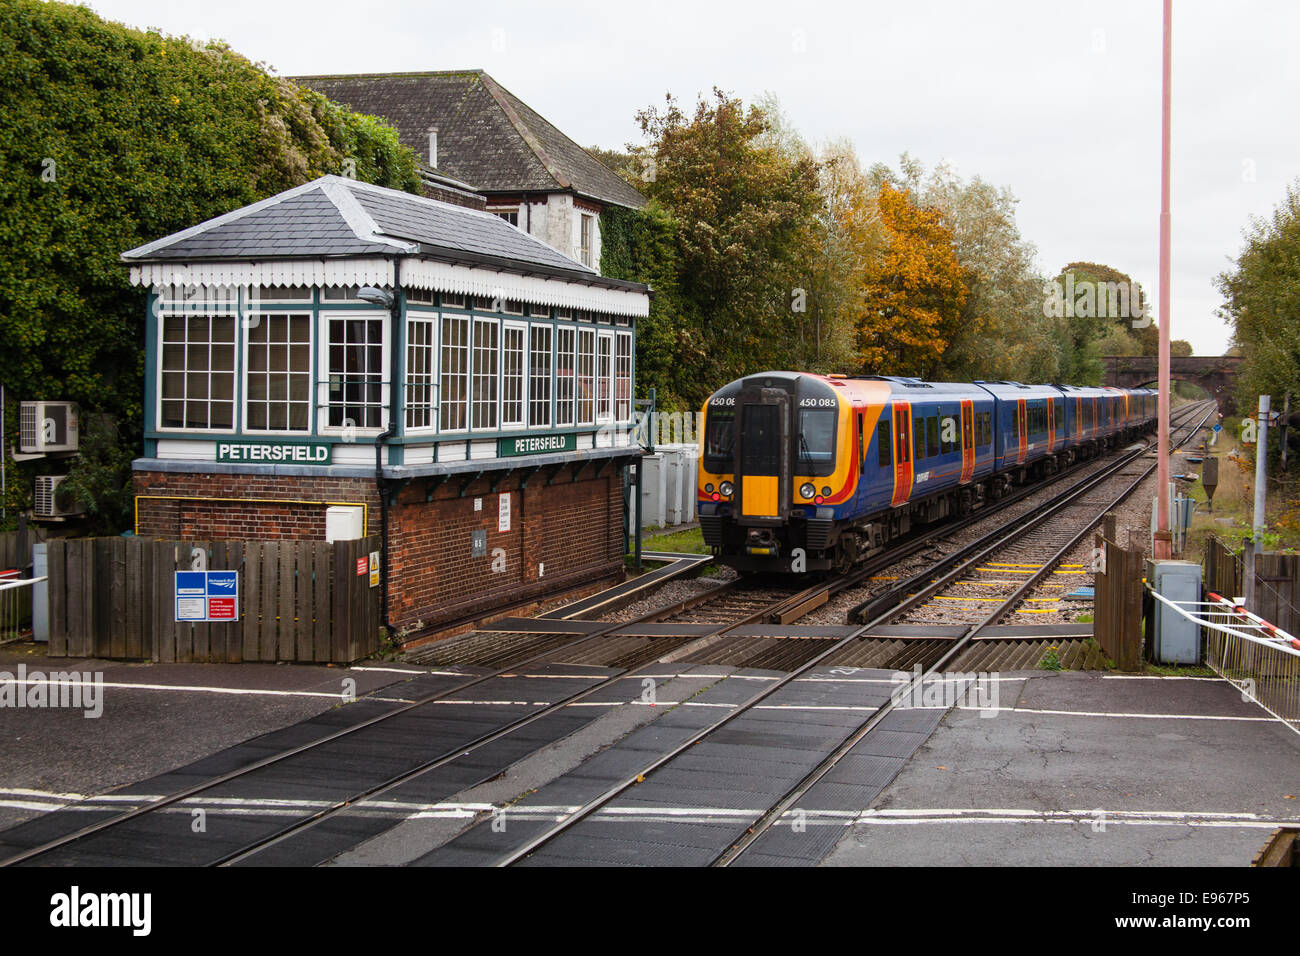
[[159, 315, 235, 429]]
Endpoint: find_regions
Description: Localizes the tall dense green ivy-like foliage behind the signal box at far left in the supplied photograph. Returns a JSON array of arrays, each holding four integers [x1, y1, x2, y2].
[[0, 0, 419, 529]]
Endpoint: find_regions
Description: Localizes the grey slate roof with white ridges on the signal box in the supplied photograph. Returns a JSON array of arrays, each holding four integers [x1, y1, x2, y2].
[[122, 176, 645, 289]]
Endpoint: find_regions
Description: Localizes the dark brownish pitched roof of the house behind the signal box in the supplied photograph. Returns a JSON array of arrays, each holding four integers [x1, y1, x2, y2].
[[291, 70, 645, 208]]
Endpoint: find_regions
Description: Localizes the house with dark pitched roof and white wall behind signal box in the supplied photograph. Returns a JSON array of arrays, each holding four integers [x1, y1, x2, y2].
[[293, 70, 645, 271]]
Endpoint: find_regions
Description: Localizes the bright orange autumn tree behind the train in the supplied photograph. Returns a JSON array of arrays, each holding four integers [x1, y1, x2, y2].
[[858, 182, 969, 377]]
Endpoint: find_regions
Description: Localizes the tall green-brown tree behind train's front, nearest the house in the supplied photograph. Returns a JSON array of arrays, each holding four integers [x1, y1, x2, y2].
[[637, 88, 820, 407]]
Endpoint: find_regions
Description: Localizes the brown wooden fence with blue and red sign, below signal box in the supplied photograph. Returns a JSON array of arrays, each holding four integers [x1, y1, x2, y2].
[[48, 537, 380, 663]]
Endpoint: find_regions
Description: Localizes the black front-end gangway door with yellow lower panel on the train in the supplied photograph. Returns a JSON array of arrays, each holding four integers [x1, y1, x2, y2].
[[736, 389, 792, 524]]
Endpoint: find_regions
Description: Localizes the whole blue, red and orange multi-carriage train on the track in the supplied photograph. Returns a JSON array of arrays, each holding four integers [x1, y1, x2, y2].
[[697, 372, 1157, 575]]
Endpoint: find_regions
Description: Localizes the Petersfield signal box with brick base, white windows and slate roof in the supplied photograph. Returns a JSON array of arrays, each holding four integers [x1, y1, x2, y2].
[[122, 177, 649, 635]]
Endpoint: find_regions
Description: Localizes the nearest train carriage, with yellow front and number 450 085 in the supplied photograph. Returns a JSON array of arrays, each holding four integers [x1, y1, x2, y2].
[[697, 372, 995, 571]]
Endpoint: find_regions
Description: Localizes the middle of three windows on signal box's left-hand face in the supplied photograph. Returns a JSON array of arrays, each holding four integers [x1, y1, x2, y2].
[[244, 313, 312, 432]]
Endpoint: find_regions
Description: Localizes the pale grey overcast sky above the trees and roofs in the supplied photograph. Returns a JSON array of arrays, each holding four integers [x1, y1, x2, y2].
[[87, 0, 1300, 355]]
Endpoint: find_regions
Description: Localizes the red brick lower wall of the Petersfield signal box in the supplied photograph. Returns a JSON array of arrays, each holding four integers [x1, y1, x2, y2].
[[135, 464, 623, 639]]
